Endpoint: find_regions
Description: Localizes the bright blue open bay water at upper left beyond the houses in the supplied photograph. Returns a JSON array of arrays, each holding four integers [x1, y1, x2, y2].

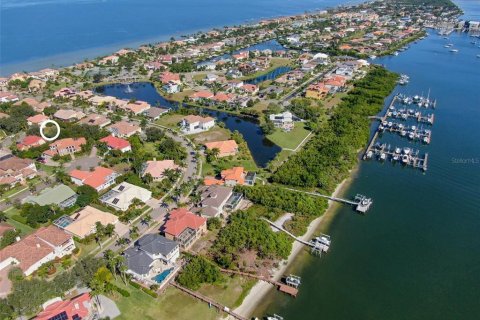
[[0, 0, 360, 75]]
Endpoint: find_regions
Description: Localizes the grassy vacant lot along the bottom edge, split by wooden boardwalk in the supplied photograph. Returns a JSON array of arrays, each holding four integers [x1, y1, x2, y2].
[[113, 277, 254, 320]]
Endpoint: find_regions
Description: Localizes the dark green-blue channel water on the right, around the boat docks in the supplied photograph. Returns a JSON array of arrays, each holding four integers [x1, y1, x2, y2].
[[257, 1, 480, 320]]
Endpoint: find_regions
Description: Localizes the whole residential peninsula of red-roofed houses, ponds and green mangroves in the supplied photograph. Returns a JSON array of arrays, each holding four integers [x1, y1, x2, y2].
[[0, 0, 464, 319]]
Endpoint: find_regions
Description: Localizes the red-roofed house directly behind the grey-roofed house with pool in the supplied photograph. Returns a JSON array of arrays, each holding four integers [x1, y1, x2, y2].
[[163, 208, 207, 249]]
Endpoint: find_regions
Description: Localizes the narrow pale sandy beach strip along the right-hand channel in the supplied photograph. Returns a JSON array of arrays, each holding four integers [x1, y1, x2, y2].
[[234, 173, 352, 318]]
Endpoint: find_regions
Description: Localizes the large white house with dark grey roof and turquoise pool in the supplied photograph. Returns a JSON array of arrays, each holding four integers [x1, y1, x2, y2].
[[123, 234, 180, 283]]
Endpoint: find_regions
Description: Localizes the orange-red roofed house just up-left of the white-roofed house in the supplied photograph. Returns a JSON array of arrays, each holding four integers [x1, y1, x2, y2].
[[70, 167, 119, 192]]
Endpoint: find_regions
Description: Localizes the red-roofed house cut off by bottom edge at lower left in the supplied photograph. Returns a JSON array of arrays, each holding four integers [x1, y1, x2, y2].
[[33, 292, 94, 320]]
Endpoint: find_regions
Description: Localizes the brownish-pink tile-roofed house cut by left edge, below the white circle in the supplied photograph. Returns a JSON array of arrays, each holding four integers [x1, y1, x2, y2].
[[0, 155, 37, 187]]
